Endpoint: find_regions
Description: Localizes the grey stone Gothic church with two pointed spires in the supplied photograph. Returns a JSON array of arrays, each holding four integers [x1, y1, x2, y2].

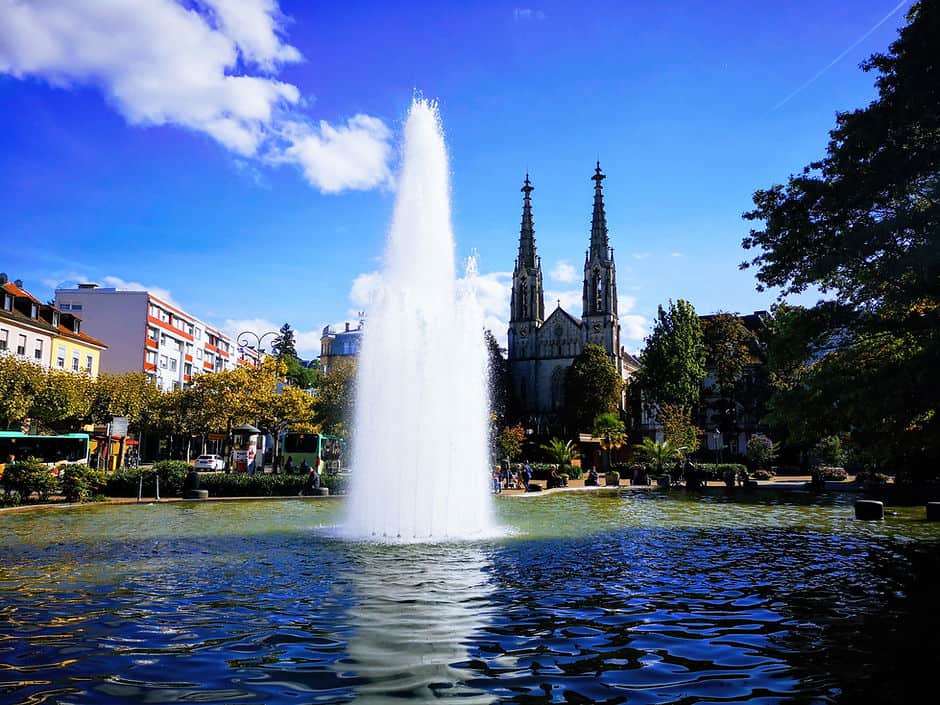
[[508, 162, 638, 433]]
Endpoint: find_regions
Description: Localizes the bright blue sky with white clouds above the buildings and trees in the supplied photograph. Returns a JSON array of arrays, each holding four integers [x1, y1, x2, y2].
[[0, 0, 910, 356]]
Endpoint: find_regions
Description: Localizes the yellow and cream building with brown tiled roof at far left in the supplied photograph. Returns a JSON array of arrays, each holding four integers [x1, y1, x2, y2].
[[0, 273, 107, 377]]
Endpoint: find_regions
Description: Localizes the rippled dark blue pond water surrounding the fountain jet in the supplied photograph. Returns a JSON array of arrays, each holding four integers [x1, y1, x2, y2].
[[0, 491, 940, 705]]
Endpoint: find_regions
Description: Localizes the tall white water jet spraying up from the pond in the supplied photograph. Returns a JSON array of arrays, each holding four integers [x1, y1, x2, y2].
[[344, 99, 493, 541]]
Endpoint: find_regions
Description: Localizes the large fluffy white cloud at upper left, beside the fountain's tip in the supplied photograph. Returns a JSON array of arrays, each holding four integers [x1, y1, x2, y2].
[[0, 0, 392, 192]]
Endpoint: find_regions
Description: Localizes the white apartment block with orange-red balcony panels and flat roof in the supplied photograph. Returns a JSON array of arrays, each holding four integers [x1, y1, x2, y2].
[[55, 284, 239, 391]]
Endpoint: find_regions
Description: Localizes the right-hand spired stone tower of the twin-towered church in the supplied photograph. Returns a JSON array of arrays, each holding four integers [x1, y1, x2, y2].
[[581, 162, 620, 360]]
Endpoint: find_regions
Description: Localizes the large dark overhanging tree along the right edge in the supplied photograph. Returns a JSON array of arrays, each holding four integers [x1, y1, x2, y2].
[[742, 0, 940, 479]]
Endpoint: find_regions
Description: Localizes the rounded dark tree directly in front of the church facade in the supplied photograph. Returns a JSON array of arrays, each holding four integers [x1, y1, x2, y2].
[[565, 343, 623, 430]]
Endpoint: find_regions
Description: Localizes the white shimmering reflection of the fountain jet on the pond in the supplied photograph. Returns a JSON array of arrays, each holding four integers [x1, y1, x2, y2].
[[336, 544, 496, 705]]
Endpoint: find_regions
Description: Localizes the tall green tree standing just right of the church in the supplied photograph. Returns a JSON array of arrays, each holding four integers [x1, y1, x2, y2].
[[635, 299, 705, 418]]
